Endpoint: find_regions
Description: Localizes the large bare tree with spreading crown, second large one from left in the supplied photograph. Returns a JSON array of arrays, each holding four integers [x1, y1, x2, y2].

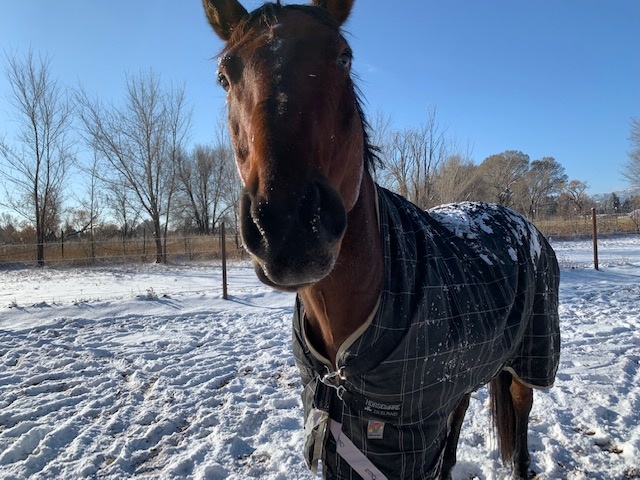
[[78, 71, 191, 262]]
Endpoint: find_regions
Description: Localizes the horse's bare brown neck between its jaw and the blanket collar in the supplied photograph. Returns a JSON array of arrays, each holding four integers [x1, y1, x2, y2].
[[298, 172, 384, 366]]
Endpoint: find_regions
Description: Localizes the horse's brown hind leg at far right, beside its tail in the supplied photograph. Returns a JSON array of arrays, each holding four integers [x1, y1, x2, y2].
[[509, 378, 533, 479]]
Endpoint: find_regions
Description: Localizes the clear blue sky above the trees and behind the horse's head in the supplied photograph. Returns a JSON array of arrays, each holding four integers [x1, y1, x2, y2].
[[0, 0, 640, 193]]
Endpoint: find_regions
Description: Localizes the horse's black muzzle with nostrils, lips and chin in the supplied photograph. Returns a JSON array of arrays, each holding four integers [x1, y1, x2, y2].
[[240, 175, 347, 291]]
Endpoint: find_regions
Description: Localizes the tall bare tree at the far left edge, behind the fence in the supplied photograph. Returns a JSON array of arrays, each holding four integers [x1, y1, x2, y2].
[[0, 50, 75, 266]]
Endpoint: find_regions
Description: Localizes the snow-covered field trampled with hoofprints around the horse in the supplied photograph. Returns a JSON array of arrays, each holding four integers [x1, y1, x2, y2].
[[0, 236, 640, 480]]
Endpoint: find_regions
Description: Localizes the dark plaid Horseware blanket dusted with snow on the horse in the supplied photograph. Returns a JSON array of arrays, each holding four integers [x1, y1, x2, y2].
[[293, 183, 560, 480]]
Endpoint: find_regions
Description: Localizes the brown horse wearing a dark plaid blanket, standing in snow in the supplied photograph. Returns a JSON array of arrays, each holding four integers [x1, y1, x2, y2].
[[203, 0, 560, 479]]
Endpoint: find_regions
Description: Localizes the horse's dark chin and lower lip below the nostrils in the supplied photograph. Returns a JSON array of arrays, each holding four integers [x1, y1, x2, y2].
[[253, 256, 335, 292]]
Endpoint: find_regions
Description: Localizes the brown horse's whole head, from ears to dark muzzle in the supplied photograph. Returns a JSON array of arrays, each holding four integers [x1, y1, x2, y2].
[[203, 0, 366, 290]]
